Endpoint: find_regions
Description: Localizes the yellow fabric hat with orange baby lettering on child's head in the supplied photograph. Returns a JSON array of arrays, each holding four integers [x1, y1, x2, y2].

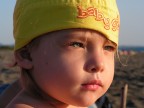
[[14, 0, 120, 50]]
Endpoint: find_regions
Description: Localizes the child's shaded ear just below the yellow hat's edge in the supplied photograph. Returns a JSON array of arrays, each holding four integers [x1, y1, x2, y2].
[[14, 51, 33, 69]]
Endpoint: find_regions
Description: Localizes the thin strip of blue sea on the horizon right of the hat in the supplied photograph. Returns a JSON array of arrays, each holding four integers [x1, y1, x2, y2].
[[119, 46, 144, 52]]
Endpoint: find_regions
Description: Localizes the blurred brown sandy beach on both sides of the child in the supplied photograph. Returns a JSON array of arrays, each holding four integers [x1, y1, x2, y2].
[[0, 49, 144, 108]]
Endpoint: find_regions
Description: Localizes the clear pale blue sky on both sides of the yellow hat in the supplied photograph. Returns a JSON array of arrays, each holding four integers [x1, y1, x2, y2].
[[0, 0, 144, 46]]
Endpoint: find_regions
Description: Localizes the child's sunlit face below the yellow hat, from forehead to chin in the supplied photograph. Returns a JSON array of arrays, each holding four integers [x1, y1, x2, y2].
[[28, 29, 116, 106]]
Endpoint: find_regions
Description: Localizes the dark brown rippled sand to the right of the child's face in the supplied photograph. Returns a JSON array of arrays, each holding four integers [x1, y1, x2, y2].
[[107, 53, 144, 108]]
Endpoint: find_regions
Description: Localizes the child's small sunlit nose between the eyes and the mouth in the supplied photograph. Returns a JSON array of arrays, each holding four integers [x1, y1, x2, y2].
[[86, 52, 104, 73]]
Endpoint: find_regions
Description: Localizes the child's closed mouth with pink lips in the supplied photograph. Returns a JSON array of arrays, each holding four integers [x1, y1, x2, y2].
[[82, 80, 103, 91]]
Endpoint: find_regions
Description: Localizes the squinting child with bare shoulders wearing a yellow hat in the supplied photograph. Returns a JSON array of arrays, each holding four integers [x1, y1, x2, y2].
[[7, 0, 119, 108]]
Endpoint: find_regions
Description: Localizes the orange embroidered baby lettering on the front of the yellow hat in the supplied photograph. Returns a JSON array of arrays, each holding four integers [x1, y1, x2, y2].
[[77, 6, 119, 31]]
